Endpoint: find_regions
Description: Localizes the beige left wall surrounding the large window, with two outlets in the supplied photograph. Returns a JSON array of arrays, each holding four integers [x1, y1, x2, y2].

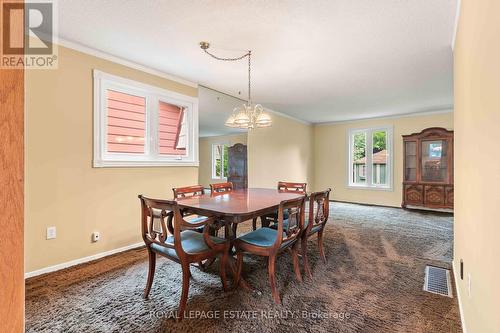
[[25, 47, 198, 272]]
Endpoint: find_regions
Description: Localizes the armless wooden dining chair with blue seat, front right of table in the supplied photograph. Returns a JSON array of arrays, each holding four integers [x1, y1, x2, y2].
[[234, 196, 305, 304]]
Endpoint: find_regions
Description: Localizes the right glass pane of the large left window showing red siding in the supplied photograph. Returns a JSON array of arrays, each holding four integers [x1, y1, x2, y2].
[[158, 102, 186, 155]]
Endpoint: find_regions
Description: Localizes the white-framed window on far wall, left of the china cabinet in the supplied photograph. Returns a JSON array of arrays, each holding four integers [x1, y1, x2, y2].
[[348, 127, 392, 189]]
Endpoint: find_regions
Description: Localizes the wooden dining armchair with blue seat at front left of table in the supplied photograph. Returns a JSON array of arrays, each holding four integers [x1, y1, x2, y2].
[[139, 195, 229, 320]]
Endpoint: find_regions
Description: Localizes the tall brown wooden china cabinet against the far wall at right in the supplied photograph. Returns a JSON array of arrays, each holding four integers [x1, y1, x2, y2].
[[401, 127, 453, 209]]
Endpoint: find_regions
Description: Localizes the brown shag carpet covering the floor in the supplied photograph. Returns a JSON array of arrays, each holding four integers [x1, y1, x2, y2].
[[26, 203, 461, 332]]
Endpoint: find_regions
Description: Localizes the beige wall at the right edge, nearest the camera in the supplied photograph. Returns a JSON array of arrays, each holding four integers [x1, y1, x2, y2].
[[454, 0, 500, 333]]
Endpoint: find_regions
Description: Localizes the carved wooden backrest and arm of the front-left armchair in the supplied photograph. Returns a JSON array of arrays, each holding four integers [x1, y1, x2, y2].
[[139, 195, 213, 259]]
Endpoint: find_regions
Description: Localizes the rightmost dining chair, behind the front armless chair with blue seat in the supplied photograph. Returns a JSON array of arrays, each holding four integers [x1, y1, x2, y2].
[[301, 188, 331, 278]]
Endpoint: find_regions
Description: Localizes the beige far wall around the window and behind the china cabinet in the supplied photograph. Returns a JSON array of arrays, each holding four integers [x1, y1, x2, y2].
[[314, 112, 453, 207]]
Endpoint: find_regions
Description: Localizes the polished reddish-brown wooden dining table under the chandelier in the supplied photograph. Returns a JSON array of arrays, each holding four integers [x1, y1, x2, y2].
[[175, 188, 304, 289]]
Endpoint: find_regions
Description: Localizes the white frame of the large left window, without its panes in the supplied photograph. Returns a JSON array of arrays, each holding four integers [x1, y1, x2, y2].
[[93, 70, 199, 168]]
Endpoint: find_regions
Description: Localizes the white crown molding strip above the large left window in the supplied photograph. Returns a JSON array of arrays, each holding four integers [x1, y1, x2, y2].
[[57, 38, 198, 88]]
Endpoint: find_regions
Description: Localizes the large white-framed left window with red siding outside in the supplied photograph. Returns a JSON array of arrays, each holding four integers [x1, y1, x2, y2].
[[94, 70, 198, 167]]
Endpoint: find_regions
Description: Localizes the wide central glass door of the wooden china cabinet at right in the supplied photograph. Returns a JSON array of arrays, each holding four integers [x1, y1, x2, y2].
[[422, 140, 448, 183]]
